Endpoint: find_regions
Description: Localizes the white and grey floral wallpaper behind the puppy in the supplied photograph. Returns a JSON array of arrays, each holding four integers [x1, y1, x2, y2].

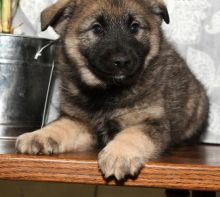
[[17, 0, 220, 143]]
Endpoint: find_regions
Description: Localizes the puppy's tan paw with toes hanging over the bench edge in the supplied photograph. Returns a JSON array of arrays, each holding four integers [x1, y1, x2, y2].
[[98, 140, 147, 180]]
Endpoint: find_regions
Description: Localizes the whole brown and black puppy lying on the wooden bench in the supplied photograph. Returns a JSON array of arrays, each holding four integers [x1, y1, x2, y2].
[[16, 0, 208, 180]]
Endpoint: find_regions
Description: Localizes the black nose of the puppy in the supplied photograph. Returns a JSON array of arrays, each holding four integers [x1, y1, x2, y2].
[[112, 54, 131, 68]]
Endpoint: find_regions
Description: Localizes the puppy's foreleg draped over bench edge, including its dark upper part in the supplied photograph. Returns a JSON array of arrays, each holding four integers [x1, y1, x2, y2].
[[98, 117, 170, 180]]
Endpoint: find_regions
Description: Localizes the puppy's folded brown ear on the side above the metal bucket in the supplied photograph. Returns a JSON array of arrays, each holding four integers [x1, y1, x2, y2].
[[41, 0, 70, 31]]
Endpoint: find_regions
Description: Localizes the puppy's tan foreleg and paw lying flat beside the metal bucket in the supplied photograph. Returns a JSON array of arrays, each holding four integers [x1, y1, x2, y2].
[[16, 118, 94, 154]]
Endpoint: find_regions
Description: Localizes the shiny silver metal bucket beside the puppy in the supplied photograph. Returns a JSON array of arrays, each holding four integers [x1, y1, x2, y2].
[[0, 34, 53, 139]]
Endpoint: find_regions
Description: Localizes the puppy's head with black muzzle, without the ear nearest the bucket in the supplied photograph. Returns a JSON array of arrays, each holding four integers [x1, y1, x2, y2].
[[41, 0, 169, 85]]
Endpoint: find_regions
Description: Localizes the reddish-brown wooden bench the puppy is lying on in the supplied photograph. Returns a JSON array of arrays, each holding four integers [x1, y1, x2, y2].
[[0, 139, 220, 197]]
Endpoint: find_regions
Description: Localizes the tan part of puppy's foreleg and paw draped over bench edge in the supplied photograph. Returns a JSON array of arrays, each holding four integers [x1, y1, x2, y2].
[[98, 126, 158, 180]]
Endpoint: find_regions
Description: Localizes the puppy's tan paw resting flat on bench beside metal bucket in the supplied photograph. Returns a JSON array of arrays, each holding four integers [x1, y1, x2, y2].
[[15, 131, 60, 155]]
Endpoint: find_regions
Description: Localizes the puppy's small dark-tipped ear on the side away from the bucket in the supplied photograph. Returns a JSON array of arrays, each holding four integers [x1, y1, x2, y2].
[[147, 0, 170, 24]]
